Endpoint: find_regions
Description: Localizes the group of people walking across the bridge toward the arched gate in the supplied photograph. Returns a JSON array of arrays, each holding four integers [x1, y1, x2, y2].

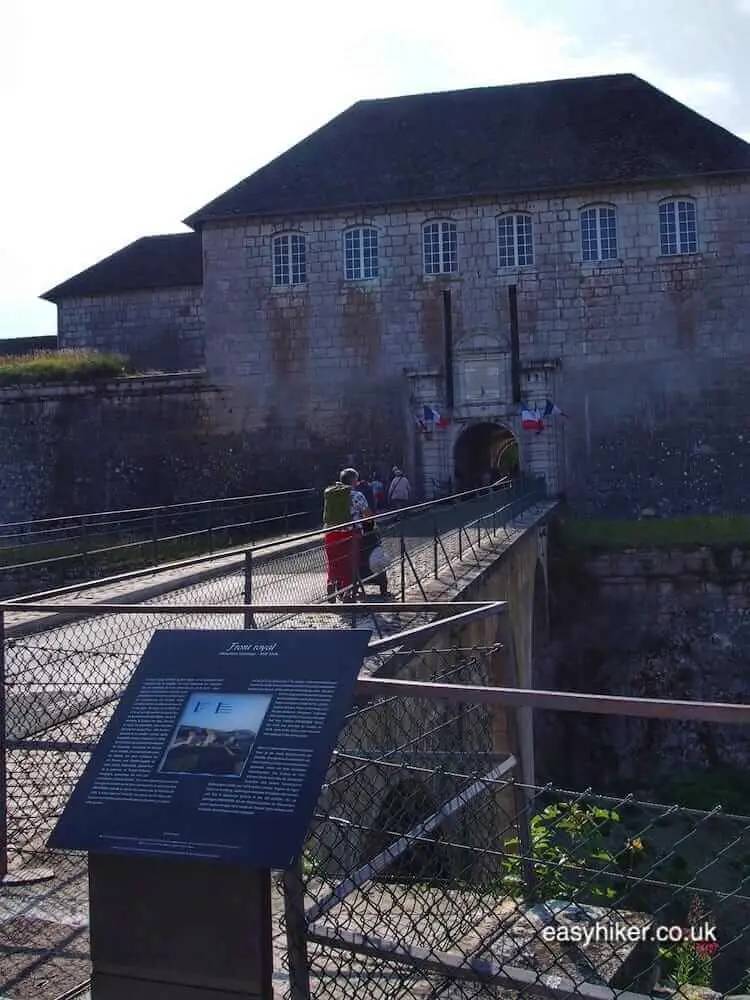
[[323, 466, 411, 601]]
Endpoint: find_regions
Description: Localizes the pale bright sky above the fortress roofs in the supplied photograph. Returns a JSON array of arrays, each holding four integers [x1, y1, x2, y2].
[[0, 0, 750, 337]]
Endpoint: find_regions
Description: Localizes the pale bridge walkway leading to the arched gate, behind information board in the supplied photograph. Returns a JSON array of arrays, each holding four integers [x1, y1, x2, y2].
[[0, 487, 556, 1000]]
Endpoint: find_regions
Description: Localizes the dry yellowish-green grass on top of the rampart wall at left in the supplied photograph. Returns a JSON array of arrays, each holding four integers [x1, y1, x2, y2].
[[0, 348, 131, 386]]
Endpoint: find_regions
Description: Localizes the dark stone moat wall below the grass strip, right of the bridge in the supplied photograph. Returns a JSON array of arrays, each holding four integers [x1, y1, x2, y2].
[[534, 545, 750, 802]]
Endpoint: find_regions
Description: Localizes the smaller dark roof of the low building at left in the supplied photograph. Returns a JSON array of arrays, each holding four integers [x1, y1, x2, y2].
[[40, 233, 203, 302]]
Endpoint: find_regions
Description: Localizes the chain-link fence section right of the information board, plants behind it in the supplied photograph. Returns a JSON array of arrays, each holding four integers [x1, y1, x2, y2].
[[279, 664, 750, 1000]]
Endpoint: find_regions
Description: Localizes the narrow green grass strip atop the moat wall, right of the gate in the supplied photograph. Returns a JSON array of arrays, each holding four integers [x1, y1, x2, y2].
[[560, 514, 750, 549]]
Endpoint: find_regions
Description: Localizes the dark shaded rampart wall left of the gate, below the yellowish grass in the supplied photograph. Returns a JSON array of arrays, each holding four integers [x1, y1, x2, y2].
[[0, 374, 308, 523]]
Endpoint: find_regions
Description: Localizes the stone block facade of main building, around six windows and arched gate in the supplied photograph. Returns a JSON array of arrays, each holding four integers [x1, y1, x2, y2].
[[203, 173, 750, 515]]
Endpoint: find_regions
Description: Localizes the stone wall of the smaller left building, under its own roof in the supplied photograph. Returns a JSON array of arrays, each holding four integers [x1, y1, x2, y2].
[[57, 286, 205, 372]]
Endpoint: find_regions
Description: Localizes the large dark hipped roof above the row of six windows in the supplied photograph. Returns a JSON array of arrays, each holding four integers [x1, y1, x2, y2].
[[185, 74, 750, 227]]
